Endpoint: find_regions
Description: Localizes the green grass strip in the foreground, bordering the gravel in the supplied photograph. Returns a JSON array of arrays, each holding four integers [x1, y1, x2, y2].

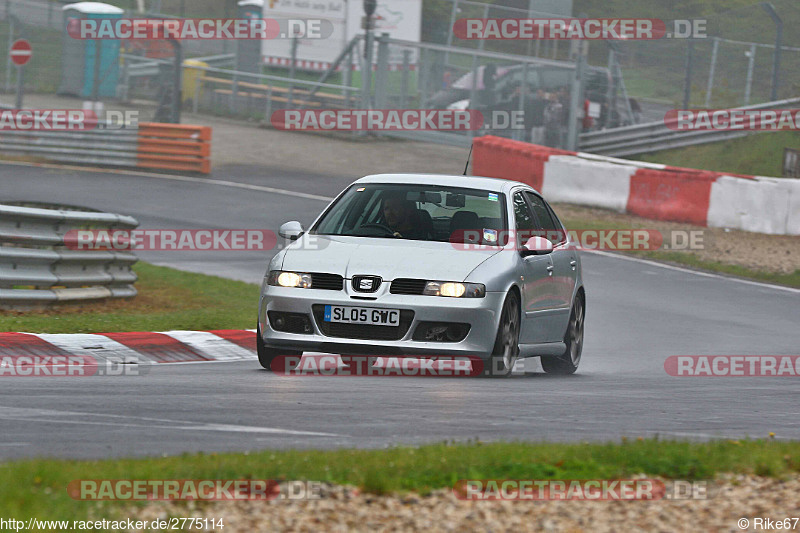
[[0, 439, 800, 520]]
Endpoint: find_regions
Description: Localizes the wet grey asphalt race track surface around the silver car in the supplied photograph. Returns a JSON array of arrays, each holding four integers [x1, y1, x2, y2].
[[0, 165, 800, 458]]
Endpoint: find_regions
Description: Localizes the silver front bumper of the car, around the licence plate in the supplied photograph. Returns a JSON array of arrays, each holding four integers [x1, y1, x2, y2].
[[258, 284, 505, 359]]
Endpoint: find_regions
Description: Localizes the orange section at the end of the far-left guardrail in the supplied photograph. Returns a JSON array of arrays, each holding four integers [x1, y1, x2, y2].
[[136, 122, 211, 174]]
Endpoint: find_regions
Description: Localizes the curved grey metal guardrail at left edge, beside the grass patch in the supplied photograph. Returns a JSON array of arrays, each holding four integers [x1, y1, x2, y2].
[[0, 204, 139, 309]]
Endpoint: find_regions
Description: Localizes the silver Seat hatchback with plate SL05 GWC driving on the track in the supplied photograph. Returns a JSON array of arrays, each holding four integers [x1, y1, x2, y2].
[[257, 174, 586, 376]]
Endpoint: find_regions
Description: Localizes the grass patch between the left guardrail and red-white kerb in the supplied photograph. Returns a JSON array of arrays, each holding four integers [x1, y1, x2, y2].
[[0, 262, 258, 333]]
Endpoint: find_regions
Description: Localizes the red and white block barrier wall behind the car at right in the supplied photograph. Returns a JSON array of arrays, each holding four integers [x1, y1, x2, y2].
[[473, 136, 800, 235]]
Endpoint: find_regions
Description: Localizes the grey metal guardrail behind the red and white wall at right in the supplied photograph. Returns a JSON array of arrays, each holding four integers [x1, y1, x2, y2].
[[579, 98, 800, 157]]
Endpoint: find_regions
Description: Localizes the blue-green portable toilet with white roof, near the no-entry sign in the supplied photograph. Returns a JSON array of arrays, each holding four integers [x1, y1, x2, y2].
[[58, 2, 125, 98]]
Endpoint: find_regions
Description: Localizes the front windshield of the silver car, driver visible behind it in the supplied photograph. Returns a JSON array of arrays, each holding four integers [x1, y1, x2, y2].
[[311, 183, 506, 246]]
